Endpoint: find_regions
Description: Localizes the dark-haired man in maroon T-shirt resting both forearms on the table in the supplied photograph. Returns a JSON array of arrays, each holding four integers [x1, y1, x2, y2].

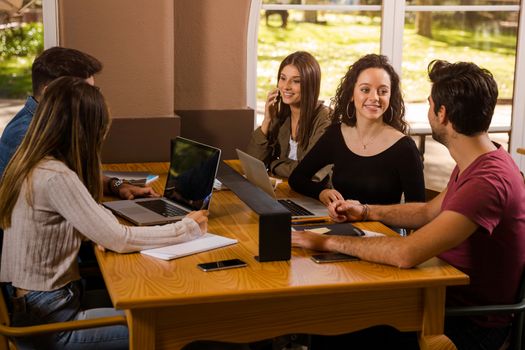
[[292, 61, 525, 349]]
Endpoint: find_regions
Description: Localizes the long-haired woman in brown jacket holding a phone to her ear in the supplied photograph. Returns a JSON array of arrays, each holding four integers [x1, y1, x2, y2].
[[248, 51, 330, 177]]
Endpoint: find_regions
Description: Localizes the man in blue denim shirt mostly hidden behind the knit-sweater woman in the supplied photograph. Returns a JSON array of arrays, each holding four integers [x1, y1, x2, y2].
[[0, 47, 156, 199]]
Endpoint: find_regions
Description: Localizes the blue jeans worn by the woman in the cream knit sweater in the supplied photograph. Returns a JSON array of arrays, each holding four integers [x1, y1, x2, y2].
[[10, 282, 128, 350]]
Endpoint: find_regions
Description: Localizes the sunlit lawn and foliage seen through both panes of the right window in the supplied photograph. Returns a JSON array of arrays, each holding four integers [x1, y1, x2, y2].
[[257, 11, 517, 102]]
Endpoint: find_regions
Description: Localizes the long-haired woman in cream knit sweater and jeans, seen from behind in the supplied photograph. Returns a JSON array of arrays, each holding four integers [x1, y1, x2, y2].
[[0, 77, 207, 349]]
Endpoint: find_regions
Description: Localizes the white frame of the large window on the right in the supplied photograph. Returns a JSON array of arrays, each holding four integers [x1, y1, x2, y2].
[[250, 0, 525, 171]]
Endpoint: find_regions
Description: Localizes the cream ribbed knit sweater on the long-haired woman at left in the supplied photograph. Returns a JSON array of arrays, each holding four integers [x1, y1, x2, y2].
[[0, 159, 202, 291]]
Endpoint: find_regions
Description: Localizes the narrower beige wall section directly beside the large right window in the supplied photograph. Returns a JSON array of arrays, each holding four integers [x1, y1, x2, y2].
[[175, 0, 250, 110]]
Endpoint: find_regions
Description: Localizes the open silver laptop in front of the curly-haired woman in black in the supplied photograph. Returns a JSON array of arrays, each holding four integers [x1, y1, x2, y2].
[[236, 149, 328, 220]]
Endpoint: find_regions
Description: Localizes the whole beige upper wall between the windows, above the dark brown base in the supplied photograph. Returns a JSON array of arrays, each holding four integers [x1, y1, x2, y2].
[[59, 0, 250, 116]]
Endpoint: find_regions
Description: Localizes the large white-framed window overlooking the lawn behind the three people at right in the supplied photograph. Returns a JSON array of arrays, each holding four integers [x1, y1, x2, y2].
[[256, 0, 525, 189]]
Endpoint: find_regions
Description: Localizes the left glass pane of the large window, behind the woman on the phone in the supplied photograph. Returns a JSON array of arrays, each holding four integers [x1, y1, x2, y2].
[[257, 10, 381, 115]]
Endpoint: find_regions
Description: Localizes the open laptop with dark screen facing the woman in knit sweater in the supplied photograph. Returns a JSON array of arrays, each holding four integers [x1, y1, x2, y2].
[[103, 137, 221, 226]]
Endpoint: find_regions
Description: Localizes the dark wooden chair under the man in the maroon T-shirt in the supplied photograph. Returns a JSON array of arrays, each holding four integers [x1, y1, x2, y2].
[[445, 271, 525, 350]]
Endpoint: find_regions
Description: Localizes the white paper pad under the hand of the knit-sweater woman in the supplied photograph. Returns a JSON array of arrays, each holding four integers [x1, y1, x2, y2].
[[141, 233, 237, 260]]
